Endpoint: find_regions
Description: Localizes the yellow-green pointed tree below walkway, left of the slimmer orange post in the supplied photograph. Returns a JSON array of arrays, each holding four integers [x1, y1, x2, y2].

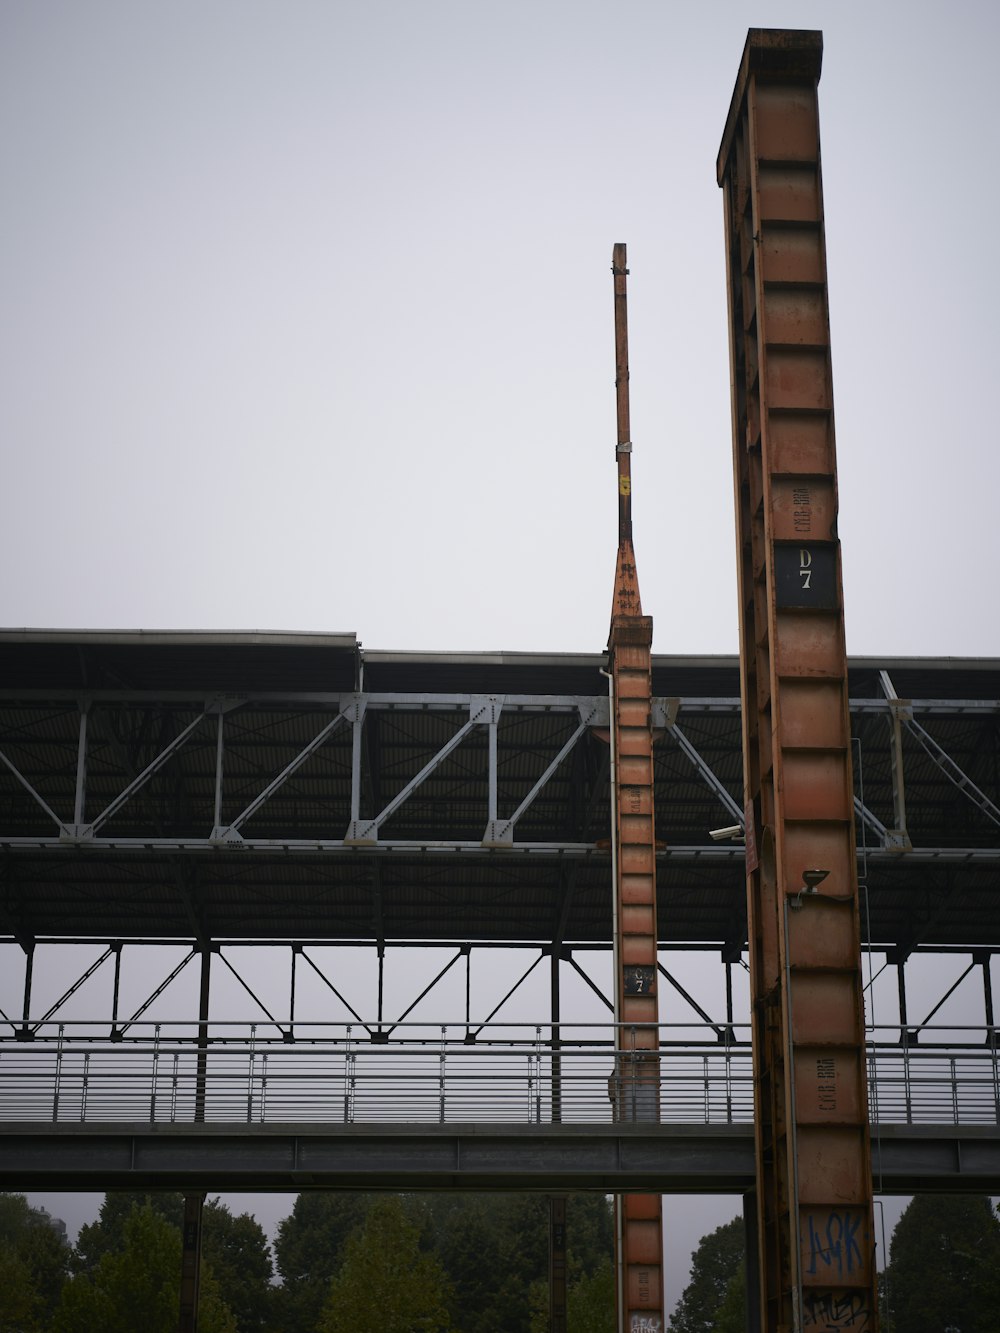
[[317, 1197, 452, 1333]]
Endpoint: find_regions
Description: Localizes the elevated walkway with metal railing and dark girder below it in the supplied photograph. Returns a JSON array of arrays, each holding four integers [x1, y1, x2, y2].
[[0, 1022, 1000, 1193]]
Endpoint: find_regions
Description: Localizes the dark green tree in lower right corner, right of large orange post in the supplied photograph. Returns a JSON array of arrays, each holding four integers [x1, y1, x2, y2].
[[887, 1194, 1000, 1333]]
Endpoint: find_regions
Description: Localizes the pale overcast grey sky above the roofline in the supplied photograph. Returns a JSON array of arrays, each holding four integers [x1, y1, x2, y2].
[[0, 0, 1000, 656]]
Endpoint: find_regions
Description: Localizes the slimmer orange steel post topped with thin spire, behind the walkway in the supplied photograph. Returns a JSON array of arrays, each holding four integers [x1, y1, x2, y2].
[[608, 245, 664, 1333]]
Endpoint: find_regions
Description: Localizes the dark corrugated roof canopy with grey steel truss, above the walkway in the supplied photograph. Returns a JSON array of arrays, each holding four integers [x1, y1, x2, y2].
[[0, 633, 1000, 957]]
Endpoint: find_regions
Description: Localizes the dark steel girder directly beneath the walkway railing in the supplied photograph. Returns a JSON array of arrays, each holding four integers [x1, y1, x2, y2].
[[0, 1124, 1000, 1194]]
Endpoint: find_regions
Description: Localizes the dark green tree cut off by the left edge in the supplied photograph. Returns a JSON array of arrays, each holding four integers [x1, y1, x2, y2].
[[0, 1194, 71, 1333]]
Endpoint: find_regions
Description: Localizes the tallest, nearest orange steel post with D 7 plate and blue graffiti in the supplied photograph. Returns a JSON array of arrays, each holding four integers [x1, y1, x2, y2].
[[717, 29, 877, 1333]]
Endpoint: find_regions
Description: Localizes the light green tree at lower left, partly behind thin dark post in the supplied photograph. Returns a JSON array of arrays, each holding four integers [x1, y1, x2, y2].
[[49, 1204, 237, 1333]]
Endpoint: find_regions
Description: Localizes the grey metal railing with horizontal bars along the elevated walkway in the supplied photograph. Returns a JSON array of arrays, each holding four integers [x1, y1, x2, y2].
[[0, 1021, 1000, 1125]]
